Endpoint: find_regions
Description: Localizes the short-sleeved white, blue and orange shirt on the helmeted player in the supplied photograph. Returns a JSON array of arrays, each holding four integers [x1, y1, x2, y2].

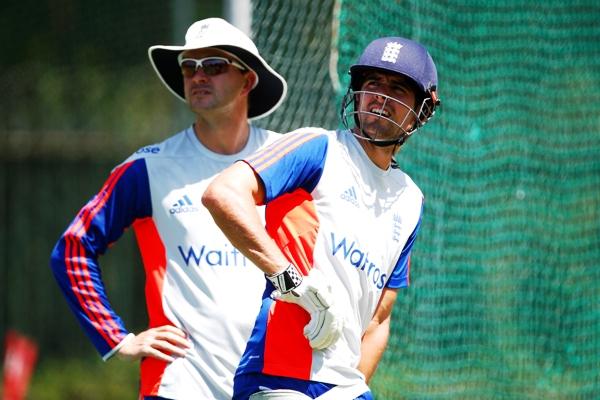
[[236, 128, 423, 385]]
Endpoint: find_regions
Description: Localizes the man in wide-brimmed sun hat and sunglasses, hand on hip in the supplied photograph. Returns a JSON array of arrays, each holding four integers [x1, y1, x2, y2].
[[51, 18, 287, 400]]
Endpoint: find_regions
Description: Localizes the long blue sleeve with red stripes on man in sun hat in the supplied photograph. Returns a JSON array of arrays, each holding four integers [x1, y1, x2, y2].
[[50, 159, 152, 357]]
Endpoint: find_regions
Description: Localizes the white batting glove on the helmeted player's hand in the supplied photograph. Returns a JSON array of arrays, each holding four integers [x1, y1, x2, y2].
[[271, 269, 343, 350]]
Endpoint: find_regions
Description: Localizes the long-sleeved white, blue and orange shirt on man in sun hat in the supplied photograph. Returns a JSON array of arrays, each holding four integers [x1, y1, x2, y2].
[[51, 127, 280, 400]]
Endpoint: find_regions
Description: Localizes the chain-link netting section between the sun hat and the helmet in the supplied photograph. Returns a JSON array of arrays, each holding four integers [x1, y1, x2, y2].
[[252, 0, 338, 132]]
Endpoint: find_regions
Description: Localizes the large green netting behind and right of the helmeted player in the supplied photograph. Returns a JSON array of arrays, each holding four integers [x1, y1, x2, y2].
[[330, 1, 600, 399]]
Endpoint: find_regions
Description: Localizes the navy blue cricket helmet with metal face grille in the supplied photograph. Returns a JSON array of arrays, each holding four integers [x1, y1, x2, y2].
[[341, 37, 440, 147]]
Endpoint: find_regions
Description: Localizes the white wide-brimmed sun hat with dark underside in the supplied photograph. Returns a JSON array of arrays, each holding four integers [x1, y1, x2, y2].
[[148, 18, 287, 119]]
